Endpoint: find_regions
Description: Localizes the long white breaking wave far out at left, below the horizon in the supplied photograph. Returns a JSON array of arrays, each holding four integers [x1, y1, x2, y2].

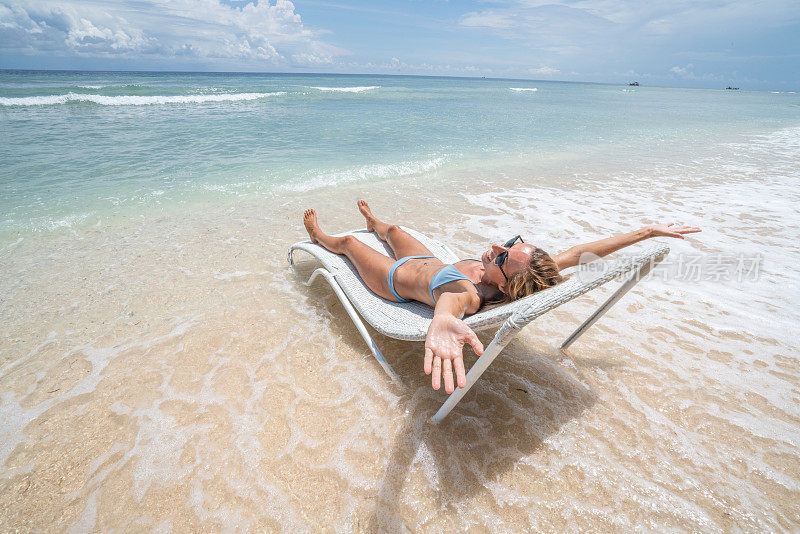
[[0, 91, 286, 106]]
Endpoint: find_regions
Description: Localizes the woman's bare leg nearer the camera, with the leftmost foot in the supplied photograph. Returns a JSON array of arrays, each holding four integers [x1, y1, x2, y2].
[[303, 209, 397, 302]]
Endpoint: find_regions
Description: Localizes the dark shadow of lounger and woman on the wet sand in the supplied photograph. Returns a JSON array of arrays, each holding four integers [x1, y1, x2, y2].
[[294, 268, 616, 532]]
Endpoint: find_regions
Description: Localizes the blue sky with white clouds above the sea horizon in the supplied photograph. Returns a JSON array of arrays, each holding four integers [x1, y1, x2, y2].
[[0, 0, 800, 89]]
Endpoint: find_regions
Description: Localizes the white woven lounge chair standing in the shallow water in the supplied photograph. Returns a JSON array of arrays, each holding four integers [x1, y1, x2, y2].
[[288, 228, 669, 422]]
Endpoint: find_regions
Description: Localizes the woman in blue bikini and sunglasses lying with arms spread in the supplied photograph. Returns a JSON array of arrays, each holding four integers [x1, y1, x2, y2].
[[303, 200, 700, 393]]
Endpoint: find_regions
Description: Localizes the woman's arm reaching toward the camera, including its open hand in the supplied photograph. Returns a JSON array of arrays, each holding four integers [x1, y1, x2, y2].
[[425, 291, 483, 393]]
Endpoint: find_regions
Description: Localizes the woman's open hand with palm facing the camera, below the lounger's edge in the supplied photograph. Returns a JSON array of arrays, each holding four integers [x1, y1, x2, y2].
[[425, 313, 483, 393]]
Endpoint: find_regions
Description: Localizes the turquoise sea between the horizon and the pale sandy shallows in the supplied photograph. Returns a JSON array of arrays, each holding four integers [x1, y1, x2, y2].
[[0, 71, 800, 232]]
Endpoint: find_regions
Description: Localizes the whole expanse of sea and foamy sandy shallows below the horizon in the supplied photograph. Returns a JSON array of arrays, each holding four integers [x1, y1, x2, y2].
[[0, 71, 800, 533]]
